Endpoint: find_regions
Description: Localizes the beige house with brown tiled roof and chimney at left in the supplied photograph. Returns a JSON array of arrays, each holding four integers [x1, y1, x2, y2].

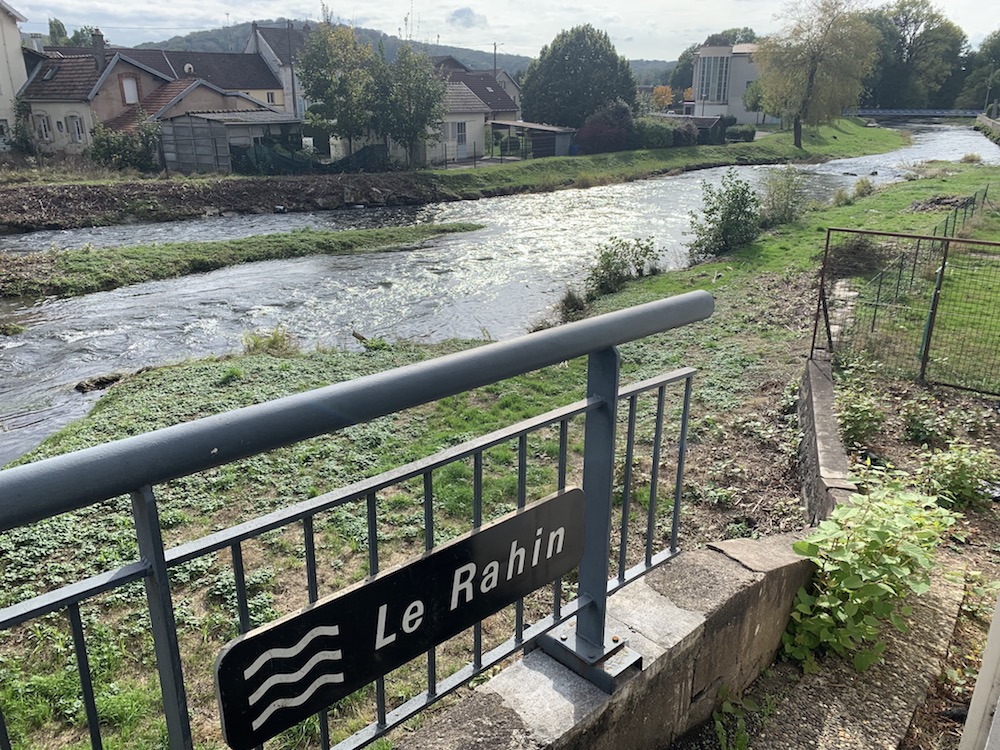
[[20, 31, 286, 161]]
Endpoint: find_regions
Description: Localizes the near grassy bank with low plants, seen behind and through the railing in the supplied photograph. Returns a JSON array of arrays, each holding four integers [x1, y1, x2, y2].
[[0, 165, 1000, 748]]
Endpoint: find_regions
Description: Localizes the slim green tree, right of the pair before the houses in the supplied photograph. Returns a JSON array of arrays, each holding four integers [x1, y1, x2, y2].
[[376, 45, 447, 166]]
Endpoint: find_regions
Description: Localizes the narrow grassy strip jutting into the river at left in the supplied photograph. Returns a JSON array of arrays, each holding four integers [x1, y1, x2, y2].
[[0, 222, 481, 298]]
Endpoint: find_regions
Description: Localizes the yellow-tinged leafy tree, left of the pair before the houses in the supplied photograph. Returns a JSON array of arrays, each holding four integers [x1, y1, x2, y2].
[[298, 21, 374, 154]]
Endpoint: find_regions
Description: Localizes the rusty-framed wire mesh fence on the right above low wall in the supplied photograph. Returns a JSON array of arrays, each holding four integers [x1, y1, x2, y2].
[[813, 189, 1000, 394]]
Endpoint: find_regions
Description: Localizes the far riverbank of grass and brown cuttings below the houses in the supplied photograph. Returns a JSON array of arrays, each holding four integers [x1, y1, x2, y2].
[[0, 120, 906, 233]]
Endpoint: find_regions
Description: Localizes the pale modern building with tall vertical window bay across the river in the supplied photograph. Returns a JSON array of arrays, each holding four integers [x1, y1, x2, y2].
[[696, 44, 772, 124]]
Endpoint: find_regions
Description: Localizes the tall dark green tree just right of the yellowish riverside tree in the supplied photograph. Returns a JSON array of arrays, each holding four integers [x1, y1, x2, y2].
[[866, 0, 966, 108]]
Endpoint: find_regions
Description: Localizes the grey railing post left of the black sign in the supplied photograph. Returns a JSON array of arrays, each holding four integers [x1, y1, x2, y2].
[[132, 486, 193, 750]]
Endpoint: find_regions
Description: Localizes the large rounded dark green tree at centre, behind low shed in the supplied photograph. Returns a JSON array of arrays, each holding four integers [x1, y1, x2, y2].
[[521, 24, 636, 128]]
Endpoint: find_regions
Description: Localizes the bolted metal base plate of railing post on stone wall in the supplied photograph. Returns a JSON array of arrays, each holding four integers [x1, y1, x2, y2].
[[538, 621, 642, 694]]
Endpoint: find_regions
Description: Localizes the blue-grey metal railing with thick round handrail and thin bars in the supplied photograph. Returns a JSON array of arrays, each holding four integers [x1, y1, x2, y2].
[[0, 292, 714, 750]]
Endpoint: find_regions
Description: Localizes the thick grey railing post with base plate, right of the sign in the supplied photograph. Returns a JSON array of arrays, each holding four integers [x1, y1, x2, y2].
[[539, 347, 640, 693]]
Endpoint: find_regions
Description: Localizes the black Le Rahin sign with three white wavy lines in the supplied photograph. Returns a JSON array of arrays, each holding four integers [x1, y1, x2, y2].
[[215, 489, 584, 750]]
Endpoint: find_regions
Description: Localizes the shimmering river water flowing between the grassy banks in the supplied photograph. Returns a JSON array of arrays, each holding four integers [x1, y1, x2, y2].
[[0, 125, 1000, 465]]
